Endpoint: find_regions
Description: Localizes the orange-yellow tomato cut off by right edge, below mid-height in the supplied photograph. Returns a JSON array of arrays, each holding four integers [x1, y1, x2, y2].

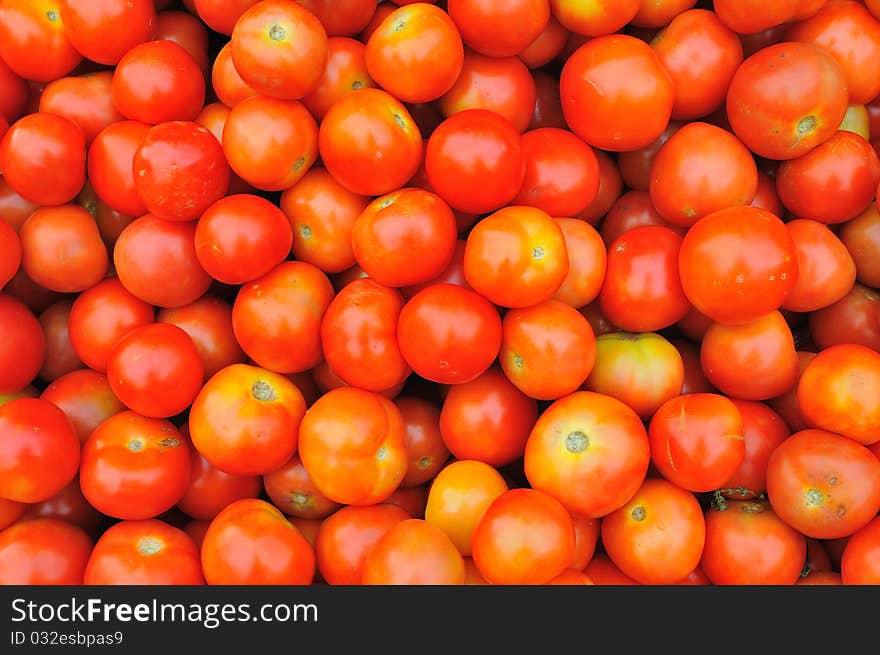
[[797, 344, 880, 445]]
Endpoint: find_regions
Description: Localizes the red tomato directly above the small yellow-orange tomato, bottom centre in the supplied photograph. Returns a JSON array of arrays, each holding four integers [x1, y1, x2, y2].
[[440, 366, 538, 467]]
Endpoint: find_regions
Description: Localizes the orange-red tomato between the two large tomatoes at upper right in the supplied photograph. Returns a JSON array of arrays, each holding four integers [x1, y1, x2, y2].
[[646, 5, 743, 120]]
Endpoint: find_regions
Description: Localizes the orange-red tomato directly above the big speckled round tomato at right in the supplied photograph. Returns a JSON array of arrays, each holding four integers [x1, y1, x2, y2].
[[650, 122, 758, 227]]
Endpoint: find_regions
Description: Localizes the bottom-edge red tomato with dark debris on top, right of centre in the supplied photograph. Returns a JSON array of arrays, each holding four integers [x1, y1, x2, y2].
[[700, 500, 807, 585]]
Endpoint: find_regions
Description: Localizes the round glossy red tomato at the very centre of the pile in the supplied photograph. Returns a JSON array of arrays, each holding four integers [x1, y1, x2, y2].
[[397, 283, 501, 384]]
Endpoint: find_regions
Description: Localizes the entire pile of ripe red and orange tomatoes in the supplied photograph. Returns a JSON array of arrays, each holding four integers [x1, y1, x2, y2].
[[0, 0, 880, 585]]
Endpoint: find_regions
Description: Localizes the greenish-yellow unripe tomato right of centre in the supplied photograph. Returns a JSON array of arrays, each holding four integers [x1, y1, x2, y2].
[[584, 332, 684, 420]]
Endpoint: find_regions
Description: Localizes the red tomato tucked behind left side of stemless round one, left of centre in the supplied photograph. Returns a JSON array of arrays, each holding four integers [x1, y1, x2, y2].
[[113, 214, 211, 307]]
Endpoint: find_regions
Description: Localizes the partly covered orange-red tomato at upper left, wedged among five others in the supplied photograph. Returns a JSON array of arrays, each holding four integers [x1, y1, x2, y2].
[[40, 71, 124, 147]]
